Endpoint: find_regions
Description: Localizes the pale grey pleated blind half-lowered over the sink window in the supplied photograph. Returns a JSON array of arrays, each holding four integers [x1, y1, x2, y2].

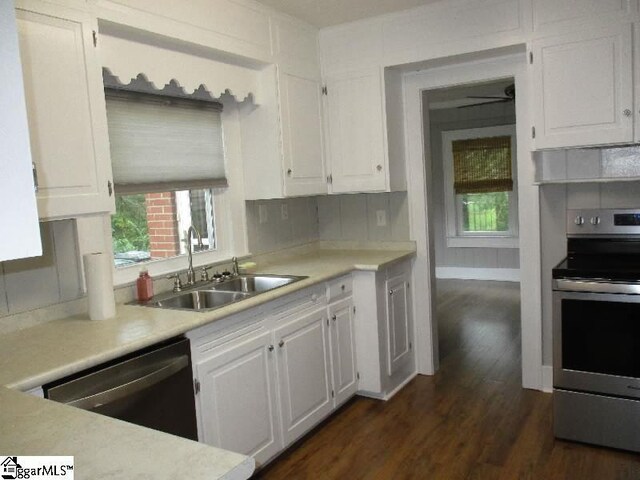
[[106, 90, 227, 194]]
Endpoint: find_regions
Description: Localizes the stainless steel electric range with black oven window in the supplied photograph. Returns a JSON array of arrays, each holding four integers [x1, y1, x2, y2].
[[553, 209, 640, 452]]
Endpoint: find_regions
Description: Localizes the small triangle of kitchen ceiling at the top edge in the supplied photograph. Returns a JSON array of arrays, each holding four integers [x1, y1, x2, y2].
[[252, 0, 441, 28]]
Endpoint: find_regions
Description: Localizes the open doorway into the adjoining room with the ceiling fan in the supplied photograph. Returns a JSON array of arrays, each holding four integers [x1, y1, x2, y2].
[[422, 77, 521, 382]]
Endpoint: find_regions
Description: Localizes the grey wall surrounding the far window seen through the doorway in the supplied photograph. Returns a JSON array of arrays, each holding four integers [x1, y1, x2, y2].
[[423, 97, 520, 275]]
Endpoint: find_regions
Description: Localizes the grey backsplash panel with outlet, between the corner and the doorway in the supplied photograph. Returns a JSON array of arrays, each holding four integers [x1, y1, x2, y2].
[[318, 192, 409, 242]]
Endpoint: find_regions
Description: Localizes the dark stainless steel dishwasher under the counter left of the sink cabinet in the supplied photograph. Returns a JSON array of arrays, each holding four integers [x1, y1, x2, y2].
[[44, 338, 198, 440]]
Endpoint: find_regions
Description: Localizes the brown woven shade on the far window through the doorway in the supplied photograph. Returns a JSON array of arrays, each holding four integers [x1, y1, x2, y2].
[[452, 136, 513, 194]]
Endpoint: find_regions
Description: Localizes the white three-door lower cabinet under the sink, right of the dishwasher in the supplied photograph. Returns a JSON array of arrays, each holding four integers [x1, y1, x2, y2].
[[187, 285, 357, 465]]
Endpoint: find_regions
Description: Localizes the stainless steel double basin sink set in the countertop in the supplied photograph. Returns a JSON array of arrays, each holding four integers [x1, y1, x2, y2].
[[145, 274, 307, 311]]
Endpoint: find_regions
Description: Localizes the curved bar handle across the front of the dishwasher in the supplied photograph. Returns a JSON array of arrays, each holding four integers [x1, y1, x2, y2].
[[66, 355, 189, 410]]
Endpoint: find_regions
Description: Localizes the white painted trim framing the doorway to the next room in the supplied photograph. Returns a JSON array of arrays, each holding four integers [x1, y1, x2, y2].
[[404, 52, 542, 390]]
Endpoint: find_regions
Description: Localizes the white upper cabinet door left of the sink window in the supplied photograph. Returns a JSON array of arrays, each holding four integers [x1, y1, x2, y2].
[[17, 6, 113, 218]]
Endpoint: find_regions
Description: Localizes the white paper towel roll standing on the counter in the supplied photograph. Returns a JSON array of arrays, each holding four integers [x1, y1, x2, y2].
[[82, 252, 116, 320]]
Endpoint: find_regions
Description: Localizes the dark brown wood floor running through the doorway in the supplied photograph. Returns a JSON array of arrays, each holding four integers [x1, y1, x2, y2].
[[256, 280, 640, 480]]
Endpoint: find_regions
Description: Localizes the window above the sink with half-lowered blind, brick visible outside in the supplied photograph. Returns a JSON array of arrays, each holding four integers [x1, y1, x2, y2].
[[106, 90, 227, 267]]
